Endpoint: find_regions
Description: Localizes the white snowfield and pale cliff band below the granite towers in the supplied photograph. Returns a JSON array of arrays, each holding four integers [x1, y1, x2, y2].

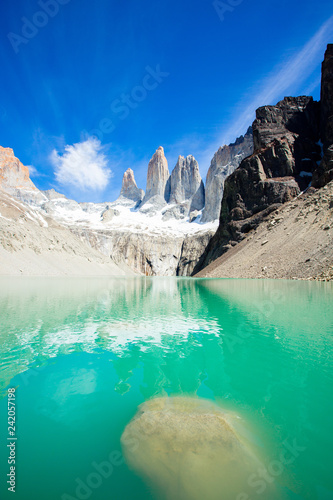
[[16, 190, 217, 276]]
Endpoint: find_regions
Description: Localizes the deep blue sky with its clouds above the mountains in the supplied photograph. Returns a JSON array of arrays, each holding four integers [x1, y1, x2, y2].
[[0, 0, 333, 201]]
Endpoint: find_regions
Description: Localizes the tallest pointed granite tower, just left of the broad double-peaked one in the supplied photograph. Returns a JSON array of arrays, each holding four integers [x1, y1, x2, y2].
[[142, 146, 170, 205]]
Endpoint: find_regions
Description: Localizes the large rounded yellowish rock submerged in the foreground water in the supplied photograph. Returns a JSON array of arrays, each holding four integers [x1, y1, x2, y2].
[[121, 397, 277, 500]]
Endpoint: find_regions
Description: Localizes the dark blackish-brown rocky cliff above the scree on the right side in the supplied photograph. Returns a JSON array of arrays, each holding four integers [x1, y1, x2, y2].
[[193, 45, 333, 274]]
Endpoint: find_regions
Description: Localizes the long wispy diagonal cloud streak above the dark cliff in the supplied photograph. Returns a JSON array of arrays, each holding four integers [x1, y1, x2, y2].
[[196, 16, 333, 177]]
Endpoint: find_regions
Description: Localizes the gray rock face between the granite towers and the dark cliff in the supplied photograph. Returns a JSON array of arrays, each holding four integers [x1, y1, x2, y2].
[[201, 127, 253, 222]]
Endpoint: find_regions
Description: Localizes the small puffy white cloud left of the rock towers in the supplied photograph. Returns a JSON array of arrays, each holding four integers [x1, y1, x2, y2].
[[50, 138, 112, 191]]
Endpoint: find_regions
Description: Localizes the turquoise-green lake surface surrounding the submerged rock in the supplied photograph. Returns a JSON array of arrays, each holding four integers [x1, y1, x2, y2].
[[0, 278, 333, 500]]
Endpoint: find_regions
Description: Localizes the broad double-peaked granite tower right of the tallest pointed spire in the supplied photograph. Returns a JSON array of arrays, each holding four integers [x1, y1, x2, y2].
[[168, 155, 205, 211]]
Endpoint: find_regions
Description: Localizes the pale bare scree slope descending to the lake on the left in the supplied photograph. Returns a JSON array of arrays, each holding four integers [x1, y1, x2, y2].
[[0, 190, 133, 276]]
